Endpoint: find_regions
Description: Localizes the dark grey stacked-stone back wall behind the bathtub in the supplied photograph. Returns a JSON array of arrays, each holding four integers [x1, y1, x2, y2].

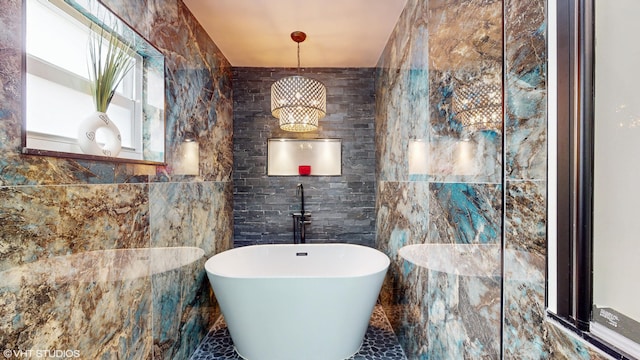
[[233, 68, 375, 246]]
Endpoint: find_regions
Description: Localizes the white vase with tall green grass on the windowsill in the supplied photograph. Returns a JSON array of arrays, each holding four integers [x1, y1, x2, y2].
[[78, 23, 134, 156]]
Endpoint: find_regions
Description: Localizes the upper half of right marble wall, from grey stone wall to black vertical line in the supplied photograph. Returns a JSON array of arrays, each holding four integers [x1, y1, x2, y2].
[[376, 1, 502, 186]]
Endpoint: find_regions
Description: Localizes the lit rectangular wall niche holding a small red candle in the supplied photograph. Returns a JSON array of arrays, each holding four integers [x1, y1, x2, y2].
[[267, 139, 342, 176]]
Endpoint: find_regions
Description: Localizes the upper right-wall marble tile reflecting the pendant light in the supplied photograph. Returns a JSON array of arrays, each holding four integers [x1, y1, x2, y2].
[[428, 0, 502, 183]]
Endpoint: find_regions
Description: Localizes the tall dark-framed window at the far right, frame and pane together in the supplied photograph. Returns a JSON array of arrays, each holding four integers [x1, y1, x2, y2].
[[549, 0, 640, 359]]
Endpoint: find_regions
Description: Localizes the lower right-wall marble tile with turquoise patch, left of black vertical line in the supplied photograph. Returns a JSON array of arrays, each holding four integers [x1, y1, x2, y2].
[[425, 183, 502, 359]]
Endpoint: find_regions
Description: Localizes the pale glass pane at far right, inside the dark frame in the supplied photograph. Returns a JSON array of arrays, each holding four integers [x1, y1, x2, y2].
[[591, 0, 640, 356]]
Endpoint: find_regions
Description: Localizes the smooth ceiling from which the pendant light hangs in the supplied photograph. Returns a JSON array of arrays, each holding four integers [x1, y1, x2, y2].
[[183, 0, 407, 68]]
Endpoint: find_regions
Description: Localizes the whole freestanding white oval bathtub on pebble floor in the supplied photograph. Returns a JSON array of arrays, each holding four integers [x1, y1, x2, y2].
[[205, 244, 389, 360]]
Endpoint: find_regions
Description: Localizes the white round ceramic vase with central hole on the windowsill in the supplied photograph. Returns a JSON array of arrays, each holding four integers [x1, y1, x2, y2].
[[78, 111, 122, 156]]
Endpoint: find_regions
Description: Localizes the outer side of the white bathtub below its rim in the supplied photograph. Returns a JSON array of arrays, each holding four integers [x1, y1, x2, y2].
[[214, 278, 381, 360]]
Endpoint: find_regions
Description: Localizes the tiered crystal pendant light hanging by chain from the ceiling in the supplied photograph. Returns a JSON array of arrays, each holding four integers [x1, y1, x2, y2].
[[271, 31, 327, 132]]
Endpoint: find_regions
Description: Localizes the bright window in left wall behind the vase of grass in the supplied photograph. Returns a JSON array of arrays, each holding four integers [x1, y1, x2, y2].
[[24, 0, 164, 162]]
